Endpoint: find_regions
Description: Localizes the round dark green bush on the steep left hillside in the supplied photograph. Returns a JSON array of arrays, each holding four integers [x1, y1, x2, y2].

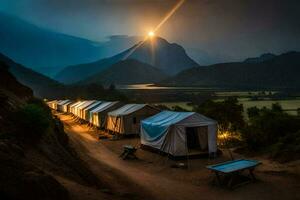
[[13, 104, 51, 140]]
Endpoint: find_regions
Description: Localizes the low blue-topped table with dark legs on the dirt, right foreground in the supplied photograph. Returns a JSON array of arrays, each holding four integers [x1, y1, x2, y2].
[[206, 159, 261, 188]]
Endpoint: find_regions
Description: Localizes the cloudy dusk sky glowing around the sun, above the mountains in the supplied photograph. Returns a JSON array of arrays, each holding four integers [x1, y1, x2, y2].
[[0, 0, 300, 62]]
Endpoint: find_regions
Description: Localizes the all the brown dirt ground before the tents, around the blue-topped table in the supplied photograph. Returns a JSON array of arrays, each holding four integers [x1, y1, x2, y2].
[[56, 113, 300, 200]]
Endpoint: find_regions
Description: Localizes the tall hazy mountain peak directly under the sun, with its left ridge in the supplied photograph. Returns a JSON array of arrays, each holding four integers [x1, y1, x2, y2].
[[55, 37, 198, 84]]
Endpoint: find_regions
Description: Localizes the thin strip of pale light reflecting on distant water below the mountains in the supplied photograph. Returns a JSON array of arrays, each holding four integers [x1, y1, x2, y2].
[[117, 83, 213, 90]]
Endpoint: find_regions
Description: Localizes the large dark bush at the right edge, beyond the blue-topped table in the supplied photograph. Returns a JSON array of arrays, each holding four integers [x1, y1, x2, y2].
[[241, 104, 300, 150]]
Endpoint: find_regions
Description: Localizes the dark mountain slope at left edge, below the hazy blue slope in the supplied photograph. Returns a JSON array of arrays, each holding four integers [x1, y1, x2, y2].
[[0, 54, 63, 97]]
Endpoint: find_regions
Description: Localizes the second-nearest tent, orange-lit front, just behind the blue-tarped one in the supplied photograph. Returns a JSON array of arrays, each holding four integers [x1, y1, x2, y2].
[[106, 104, 159, 135]]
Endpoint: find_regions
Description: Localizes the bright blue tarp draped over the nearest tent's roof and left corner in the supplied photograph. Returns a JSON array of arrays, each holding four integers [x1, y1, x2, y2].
[[142, 111, 194, 142]]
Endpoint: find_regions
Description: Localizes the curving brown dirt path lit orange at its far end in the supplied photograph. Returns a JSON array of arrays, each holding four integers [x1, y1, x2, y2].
[[58, 114, 299, 200]]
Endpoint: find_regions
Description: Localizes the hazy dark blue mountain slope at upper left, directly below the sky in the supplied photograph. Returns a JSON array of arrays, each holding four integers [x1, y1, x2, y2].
[[0, 13, 140, 76]]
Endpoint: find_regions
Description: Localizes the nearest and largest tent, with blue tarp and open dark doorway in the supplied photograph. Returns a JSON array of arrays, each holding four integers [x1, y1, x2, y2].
[[141, 111, 217, 156]]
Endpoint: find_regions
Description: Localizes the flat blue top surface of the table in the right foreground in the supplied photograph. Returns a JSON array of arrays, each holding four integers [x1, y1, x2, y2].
[[207, 159, 261, 173]]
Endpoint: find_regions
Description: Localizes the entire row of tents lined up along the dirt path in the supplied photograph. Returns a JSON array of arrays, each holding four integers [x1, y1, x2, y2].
[[47, 100, 217, 156]]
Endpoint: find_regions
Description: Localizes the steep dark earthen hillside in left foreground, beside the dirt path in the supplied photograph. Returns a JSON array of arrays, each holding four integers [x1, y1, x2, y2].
[[0, 63, 108, 200]]
